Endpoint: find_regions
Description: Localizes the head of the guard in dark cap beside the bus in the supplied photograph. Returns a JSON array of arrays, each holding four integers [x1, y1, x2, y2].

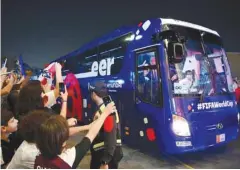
[[89, 81, 108, 102]]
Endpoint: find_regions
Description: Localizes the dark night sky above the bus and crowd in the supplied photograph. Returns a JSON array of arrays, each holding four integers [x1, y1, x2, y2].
[[1, 0, 240, 67]]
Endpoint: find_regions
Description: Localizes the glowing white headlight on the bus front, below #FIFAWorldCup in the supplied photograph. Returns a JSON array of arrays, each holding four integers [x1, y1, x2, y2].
[[172, 114, 191, 136]]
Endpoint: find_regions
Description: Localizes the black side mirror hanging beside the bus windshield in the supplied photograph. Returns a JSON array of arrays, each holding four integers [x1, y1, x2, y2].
[[168, 43, 184, 63]]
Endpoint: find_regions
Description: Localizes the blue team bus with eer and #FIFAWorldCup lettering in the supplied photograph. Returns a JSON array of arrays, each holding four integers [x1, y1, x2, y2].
[[50, 18, 239, 154]]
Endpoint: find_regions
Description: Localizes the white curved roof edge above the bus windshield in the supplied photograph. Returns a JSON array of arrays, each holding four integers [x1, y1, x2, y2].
[[160, 18, 220, 36]]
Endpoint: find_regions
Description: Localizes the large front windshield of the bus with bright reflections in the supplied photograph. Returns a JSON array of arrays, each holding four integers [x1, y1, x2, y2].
[[169, 28, 233, 96]]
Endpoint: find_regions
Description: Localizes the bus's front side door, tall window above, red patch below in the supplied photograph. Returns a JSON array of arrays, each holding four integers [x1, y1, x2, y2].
[[134, 46, 164, 152]]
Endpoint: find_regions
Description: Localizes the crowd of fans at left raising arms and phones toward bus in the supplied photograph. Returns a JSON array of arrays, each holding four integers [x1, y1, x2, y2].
[[0, 63, 116, 169]]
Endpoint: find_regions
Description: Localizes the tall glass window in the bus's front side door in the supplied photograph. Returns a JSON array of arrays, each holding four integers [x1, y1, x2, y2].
[[136, 50, 161, 105]]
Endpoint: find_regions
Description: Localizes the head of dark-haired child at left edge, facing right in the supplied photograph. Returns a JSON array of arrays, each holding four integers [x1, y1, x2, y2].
[[1, 108, 18, 134]]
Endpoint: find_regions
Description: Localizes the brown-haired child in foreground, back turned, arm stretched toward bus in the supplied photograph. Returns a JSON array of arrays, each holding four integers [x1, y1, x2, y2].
[[34, 103, 116, 169]]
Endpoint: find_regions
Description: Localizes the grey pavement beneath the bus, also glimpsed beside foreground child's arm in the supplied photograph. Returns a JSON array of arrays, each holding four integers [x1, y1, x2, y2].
[[68, 130, 240, 169]]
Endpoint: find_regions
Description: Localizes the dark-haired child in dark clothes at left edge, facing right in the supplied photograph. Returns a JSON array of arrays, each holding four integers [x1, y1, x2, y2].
[[1, 108, 18, 167]]
